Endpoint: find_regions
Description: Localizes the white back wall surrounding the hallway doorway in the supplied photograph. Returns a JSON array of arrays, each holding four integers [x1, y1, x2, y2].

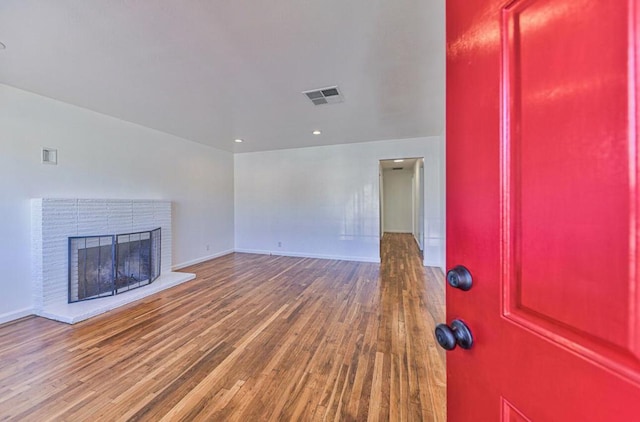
[[234, 137, 444, 267]]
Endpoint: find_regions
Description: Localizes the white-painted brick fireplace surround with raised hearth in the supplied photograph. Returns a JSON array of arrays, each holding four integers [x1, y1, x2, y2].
[[31, 198, 195, 323]]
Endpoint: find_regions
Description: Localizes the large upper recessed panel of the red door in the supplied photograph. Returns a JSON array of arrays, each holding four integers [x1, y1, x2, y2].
[[502, 0, 639, 375]]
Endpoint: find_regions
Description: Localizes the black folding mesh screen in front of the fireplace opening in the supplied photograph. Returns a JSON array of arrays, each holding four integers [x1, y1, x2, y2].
[[69, 228, 161, 303]]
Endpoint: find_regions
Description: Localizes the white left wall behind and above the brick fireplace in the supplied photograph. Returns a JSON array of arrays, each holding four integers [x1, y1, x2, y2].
[[0, 85, 234, 322]]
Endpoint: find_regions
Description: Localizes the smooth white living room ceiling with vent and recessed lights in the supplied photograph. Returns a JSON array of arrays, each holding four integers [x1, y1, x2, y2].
[[0, 0, 445, 152]]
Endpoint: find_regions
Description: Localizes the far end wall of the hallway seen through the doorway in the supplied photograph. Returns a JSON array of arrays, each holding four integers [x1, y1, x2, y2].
[[382, 168, 414, 233]]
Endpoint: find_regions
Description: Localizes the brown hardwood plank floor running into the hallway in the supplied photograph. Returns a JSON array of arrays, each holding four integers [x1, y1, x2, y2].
[[0, 234, 446, 421]]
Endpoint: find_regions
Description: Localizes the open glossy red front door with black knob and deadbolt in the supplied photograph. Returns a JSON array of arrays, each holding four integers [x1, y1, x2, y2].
[[447, 0, 640, 422]]
